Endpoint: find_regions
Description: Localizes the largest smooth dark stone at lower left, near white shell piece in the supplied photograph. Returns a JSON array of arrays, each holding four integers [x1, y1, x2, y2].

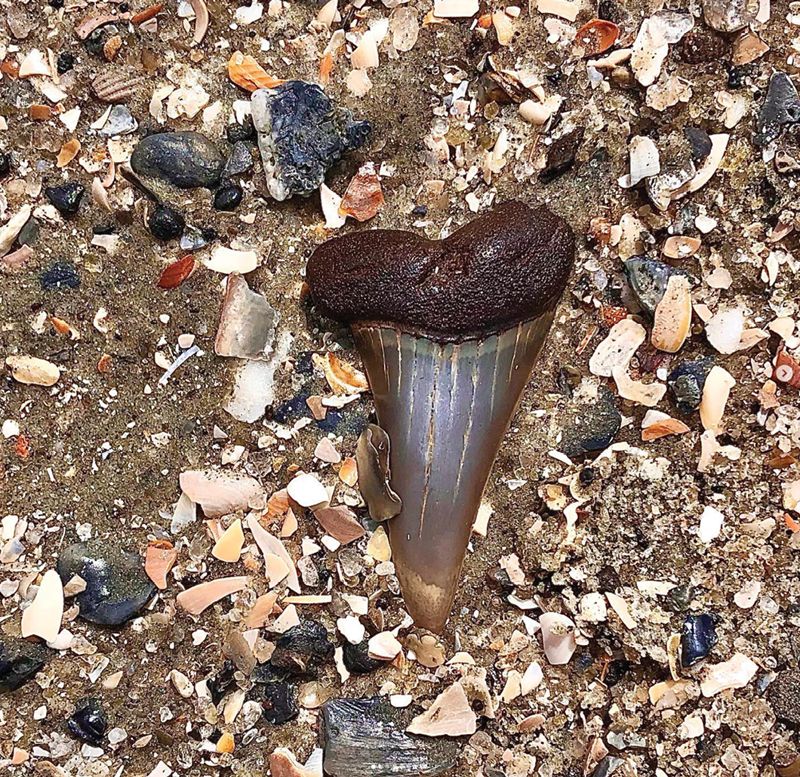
[[56, 540, 156, 626]]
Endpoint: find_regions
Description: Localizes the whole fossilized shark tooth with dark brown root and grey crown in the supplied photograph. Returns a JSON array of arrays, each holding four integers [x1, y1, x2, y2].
[[307, 202, 575, 631]]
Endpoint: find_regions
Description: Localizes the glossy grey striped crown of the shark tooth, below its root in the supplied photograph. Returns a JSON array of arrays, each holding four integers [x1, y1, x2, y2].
[[354, 311, 553, 631]]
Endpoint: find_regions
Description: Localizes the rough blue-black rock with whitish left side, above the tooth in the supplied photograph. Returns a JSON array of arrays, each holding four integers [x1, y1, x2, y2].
[[251, 81, 371, 200]]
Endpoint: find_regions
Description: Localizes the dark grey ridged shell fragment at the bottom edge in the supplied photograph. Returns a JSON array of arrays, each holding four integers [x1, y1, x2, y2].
[[322, 698, 461, 777]]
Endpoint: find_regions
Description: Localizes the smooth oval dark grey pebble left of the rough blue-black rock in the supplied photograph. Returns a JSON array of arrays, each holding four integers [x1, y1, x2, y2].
[[131, 132, 225, 189]]
